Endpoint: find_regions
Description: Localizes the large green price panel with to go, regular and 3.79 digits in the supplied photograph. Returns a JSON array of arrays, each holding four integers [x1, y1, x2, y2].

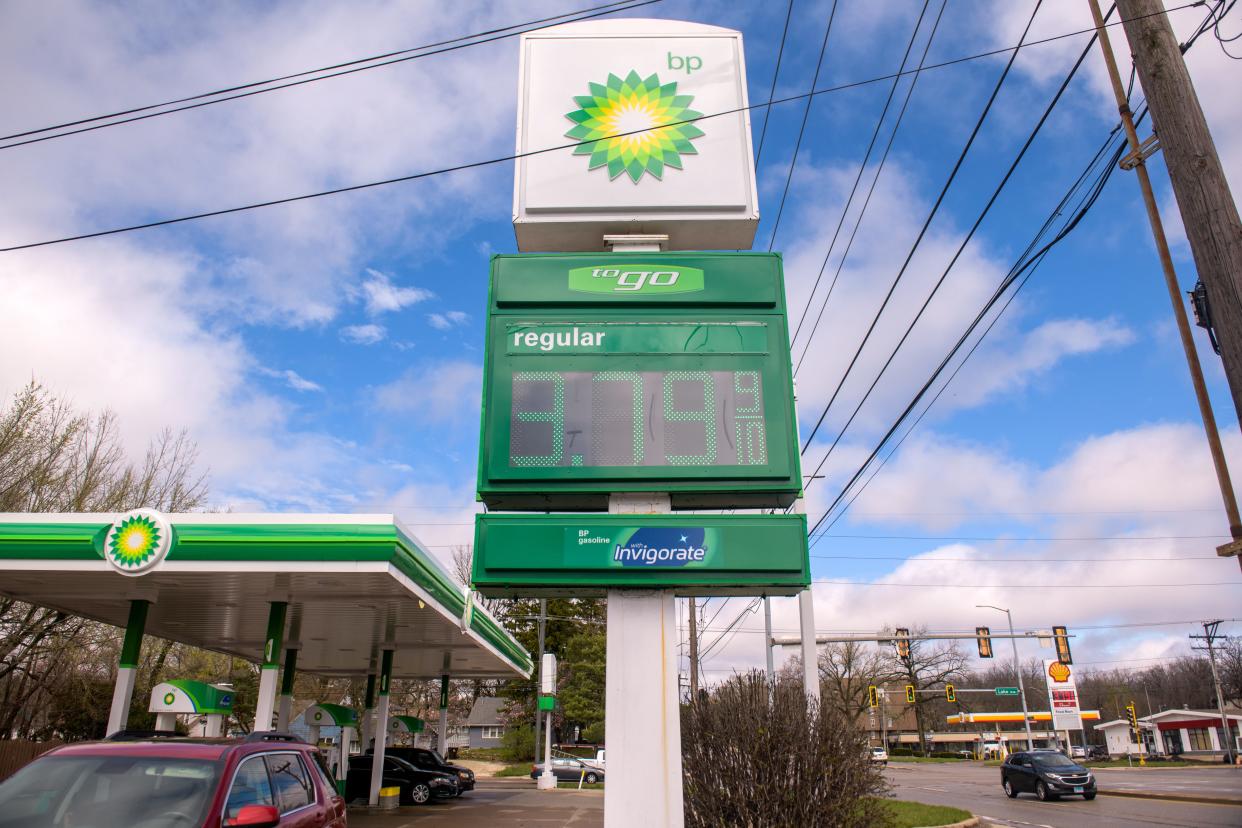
[[478, 253, 801, 510]]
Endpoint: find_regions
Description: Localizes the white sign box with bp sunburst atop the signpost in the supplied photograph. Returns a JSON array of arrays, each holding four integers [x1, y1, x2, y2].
[[513, 20, 759, 252]]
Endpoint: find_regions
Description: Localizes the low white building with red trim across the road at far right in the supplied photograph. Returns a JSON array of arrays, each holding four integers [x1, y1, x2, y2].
[[1095, 710, 1242, 758]]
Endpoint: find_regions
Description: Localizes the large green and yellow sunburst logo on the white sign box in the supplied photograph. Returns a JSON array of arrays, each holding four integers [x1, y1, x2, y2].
[[565, 70, 703, 184]]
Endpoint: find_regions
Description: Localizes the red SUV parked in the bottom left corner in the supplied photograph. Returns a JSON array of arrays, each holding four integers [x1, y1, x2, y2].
[[0, 734, 345, 828]]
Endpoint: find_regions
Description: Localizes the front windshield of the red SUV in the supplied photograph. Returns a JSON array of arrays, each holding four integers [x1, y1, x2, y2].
[[0, 756, 220, 828]]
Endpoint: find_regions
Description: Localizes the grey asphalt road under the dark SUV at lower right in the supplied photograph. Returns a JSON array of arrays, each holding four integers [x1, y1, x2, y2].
[[886, 762, 1242, 828]]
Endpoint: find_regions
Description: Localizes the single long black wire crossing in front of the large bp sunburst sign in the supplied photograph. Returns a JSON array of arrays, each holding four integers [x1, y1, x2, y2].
[[0, 2, 1199, 253]]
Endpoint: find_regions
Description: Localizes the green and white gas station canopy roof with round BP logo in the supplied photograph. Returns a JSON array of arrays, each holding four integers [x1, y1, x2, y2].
[[0, 510, 532, 679]]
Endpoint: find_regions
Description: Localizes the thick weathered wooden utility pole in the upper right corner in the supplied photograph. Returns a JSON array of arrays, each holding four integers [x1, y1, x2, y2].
[[1117, 0, 1242, 439]]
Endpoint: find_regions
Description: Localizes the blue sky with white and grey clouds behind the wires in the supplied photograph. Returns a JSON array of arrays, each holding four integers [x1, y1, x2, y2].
[[0, 0, 1242, 670]]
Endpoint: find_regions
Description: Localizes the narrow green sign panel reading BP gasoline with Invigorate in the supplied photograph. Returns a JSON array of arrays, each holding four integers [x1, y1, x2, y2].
[[473, 514, 811, 597]]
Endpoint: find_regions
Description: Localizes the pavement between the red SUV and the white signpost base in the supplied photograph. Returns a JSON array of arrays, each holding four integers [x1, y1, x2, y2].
[[349, 778, 604, 828]]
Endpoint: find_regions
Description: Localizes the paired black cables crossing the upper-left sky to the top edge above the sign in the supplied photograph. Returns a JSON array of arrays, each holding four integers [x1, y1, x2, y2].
[[0, 0, 662, 149]]
